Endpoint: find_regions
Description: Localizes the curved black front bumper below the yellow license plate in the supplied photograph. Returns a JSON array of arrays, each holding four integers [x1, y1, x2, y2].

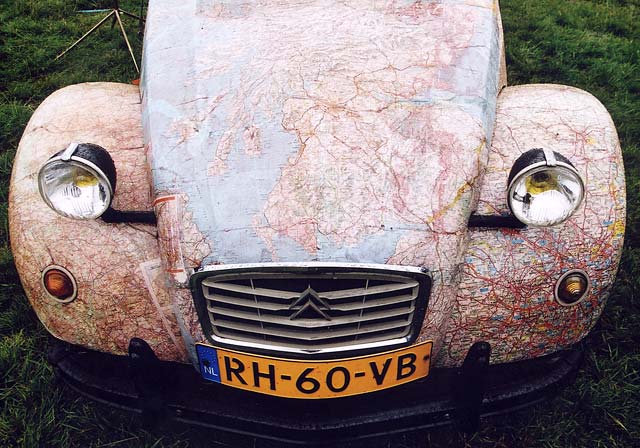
[[49, 342, 582, 445]]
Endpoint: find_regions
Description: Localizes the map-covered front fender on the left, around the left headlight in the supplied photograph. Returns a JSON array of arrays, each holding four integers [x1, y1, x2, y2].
[[9, 83, 187, 361]]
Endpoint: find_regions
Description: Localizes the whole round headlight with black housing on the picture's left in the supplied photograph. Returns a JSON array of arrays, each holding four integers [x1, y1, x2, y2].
[[38, 143, 116, 219]]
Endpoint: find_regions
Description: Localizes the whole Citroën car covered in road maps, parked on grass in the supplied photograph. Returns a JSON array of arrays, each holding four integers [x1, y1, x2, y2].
[[9, 0, 625, 443]]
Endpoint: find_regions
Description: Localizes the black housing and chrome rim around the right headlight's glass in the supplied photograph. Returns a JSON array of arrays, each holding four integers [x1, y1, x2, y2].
[[507, 148, 585, 227]]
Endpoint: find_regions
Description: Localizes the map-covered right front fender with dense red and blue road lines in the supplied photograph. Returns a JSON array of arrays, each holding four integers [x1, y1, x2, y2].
[[441, 85, 626, 364]]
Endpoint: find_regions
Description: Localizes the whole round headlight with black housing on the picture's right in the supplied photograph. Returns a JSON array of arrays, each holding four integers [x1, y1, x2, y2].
[[507, 149, 584, 226]]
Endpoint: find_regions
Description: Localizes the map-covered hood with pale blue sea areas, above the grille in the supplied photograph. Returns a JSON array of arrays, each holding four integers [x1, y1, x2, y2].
[[143, 0, 500, 272]]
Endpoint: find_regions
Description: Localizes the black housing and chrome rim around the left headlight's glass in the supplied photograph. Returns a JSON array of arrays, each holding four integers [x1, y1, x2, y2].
[[38, 142, 116, 220]]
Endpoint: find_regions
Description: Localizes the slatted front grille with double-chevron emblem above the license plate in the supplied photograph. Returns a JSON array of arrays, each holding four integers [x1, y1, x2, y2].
[[191, 266, 430, 353]]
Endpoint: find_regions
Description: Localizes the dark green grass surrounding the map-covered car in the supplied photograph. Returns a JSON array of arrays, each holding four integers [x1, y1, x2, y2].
[[0, 0, 640, 448]]
